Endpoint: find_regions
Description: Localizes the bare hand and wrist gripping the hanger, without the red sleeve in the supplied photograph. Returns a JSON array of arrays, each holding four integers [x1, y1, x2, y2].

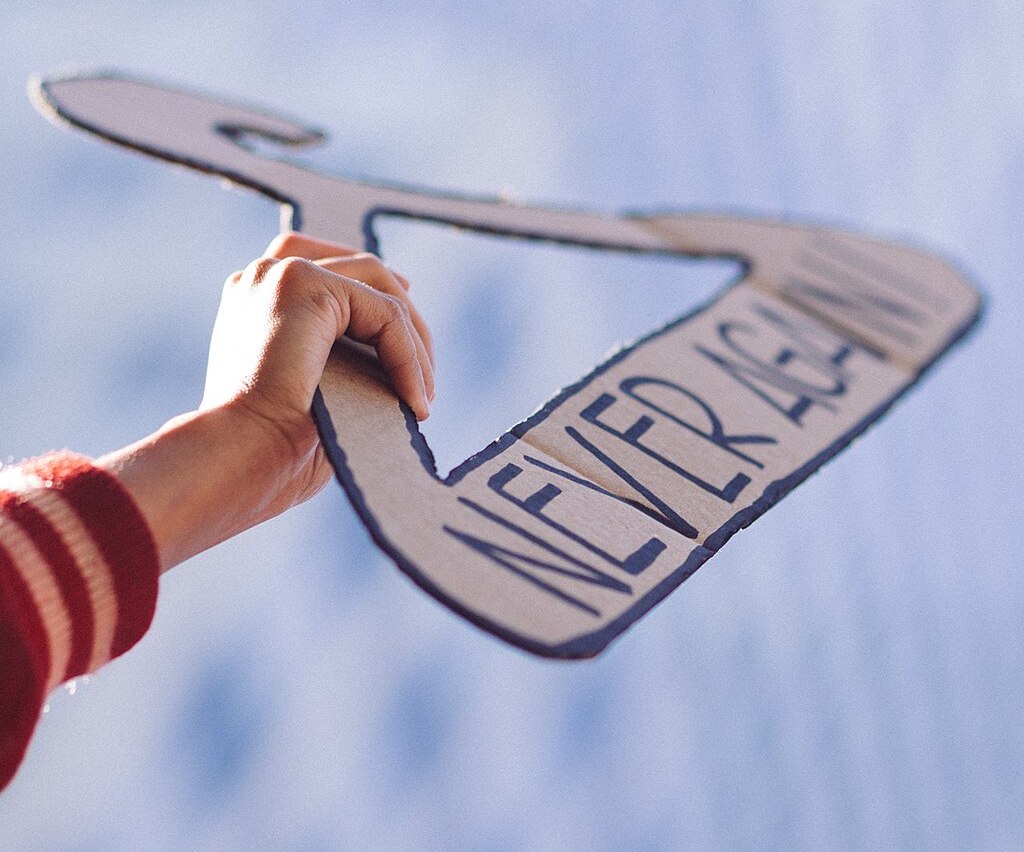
[[100, 233, 434, 570]]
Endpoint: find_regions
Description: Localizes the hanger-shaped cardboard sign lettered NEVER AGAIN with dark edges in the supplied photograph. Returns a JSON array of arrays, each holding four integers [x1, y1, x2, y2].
[[36, 76, 980, 657]]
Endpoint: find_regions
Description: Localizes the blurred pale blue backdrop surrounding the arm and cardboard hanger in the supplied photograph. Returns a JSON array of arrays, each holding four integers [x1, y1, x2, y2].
[[0, 0, 1024, 852]]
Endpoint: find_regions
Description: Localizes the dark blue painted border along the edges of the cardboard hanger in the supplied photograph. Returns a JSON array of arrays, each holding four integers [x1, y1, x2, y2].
[[36, 71, 985, 659]]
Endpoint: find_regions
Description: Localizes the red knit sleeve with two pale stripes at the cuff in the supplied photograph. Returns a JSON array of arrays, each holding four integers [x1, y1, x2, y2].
[[0, 453, 160, 790]]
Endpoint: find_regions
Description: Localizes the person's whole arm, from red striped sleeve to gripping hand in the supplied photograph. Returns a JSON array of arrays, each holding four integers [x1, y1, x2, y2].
[[0, 233, 434, 789]]
